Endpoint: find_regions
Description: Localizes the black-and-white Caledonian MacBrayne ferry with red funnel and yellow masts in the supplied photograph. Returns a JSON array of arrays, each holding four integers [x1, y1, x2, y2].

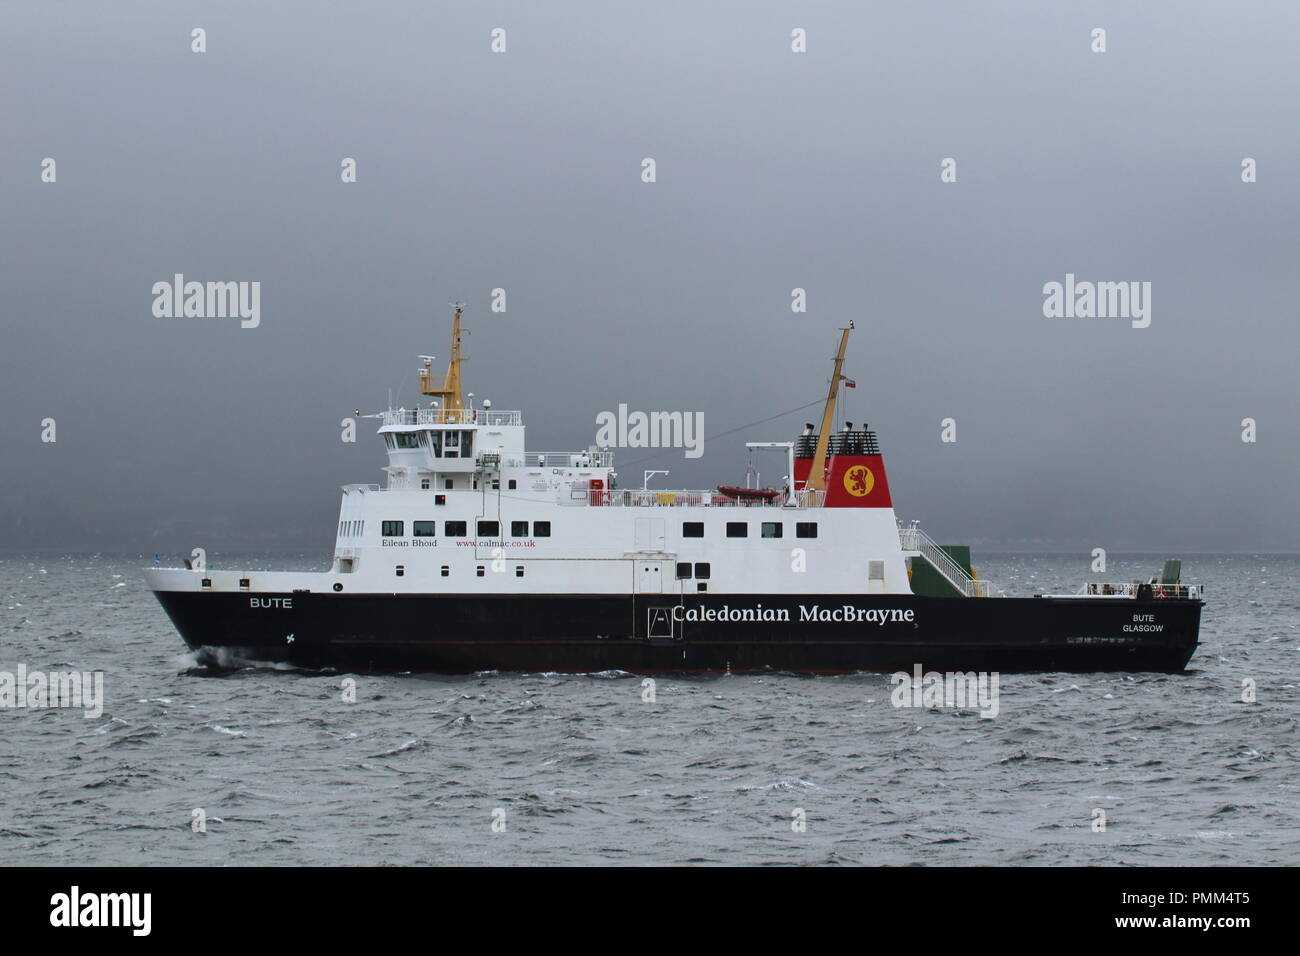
[[144, 306, 1204, 674]]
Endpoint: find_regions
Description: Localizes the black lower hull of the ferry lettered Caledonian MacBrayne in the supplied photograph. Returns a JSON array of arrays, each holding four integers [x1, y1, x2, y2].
[[156, 591, 1203, 674]]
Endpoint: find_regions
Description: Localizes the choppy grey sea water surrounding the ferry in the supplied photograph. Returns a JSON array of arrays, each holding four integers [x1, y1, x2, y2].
[[0, 555, 1300, 865]]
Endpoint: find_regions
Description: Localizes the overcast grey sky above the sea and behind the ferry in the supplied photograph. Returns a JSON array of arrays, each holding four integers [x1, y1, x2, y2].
[[0, 0, 1300, 559]]
